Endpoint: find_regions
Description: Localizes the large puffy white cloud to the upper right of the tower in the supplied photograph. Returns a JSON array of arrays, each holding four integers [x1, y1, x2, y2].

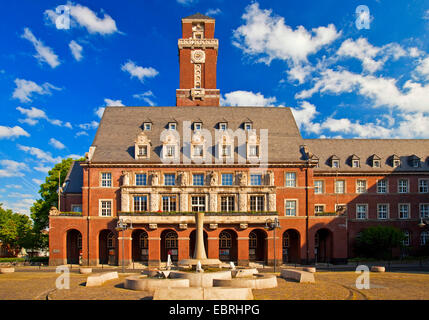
[[233, 2, 341, 64]]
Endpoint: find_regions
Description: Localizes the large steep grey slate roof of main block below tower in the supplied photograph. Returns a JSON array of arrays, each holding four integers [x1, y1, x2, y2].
[[91, 106, 303, 163]]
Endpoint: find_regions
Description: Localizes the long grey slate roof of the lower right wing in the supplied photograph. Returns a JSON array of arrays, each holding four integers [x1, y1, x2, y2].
[[303, 139, 429, 172]]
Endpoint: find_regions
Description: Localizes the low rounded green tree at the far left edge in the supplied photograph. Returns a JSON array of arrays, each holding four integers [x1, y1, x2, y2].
[[0, 203, 32, 253]]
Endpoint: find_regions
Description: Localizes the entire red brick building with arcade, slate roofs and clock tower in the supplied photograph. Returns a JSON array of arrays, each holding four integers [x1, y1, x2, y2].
[[49, 14, 429, 265]]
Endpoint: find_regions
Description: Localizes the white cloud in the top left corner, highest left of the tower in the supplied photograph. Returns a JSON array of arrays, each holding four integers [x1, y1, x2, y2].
[[44, 1, 119, 35]]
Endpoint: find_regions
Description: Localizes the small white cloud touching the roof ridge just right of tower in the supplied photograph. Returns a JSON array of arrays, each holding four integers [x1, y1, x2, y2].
[[220, 90, 276, 107]]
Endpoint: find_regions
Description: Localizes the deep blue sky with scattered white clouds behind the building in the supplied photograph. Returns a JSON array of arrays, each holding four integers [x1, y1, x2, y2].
[[0, 0, 429, 213]]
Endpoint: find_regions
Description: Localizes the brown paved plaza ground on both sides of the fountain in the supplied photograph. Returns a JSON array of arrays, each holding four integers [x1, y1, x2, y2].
[[0, 268, 429, 300]]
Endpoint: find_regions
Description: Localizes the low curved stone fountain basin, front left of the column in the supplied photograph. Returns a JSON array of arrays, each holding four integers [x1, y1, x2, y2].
[[124, 275, 189, 291]]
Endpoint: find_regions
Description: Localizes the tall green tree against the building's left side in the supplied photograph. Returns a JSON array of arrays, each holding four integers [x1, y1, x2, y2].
[[30, 158, 84, 248]]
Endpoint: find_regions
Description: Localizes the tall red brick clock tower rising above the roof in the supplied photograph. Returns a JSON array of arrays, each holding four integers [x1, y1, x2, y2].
[[176, 13, 220, 107]]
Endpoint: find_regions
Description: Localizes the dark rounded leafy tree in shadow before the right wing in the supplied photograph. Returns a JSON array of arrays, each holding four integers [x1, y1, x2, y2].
[[355, 226, 405, 259]]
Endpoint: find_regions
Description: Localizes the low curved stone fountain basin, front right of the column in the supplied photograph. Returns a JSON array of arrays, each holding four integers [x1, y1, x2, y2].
[[213, 274, 277, 289]]
